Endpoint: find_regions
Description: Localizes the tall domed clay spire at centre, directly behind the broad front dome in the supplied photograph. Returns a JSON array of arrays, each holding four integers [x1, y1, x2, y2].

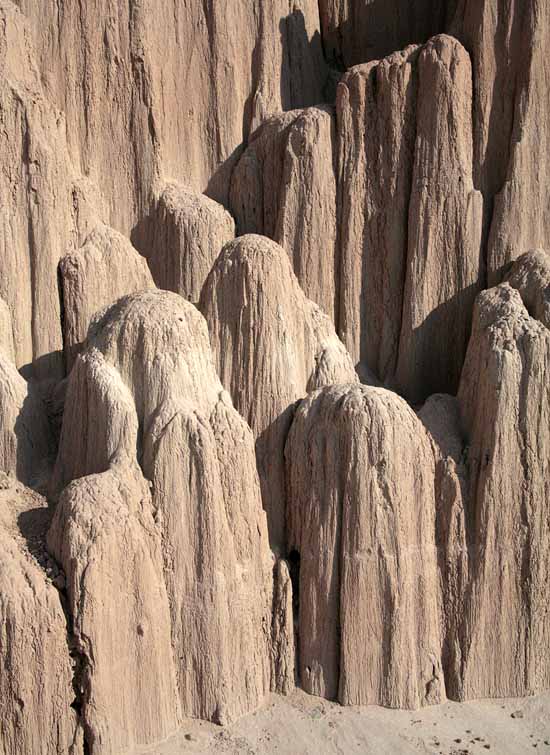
[[199, 234, 357, 548]]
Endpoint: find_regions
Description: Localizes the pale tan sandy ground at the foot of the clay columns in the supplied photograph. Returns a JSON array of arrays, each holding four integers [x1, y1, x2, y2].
[[140, 691, 550, 755]]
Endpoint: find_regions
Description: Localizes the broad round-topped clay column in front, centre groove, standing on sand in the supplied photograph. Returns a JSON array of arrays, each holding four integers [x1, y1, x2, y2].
[[286, 385, 445, 708]]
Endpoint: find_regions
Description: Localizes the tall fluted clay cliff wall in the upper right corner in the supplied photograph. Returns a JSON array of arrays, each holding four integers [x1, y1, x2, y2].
[[450, 0, 550, 281]]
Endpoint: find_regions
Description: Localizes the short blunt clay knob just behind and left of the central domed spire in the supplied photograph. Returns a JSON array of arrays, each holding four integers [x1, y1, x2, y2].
[[144, 183, 235, 302]]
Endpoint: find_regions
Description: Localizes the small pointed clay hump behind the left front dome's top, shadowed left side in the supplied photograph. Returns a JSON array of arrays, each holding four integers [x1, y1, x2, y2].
[[59, 225, 155, 372]]
